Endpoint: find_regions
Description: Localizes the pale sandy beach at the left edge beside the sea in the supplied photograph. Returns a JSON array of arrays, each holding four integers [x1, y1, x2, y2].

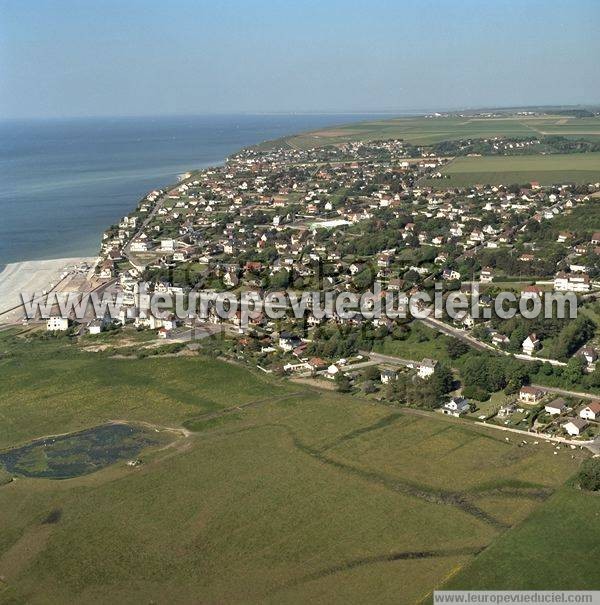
[[0, 257, 96, 323]]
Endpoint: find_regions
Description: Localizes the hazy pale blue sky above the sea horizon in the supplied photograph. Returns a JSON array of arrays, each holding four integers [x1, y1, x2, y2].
[[0, 0, 600, 117]]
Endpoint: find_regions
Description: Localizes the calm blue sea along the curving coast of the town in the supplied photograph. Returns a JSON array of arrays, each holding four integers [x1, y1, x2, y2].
[[0, 114, 385, 270]]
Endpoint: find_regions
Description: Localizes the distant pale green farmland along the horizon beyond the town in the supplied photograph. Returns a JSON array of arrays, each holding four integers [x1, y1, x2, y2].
[[284, 116, 600, 149]]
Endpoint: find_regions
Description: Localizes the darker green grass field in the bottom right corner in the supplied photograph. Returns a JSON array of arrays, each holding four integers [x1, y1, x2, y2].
[[444, 486, 600, 590]]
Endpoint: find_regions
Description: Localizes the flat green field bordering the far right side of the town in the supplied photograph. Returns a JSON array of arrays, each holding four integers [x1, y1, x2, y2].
[[422, 153, 600, 189]]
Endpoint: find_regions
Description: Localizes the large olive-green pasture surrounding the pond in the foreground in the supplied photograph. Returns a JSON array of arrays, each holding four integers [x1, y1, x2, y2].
[[0, 332, 597, 603]]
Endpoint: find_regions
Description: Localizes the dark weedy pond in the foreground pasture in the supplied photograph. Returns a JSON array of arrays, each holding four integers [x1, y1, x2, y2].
[[0, 424, 158, 479]]
